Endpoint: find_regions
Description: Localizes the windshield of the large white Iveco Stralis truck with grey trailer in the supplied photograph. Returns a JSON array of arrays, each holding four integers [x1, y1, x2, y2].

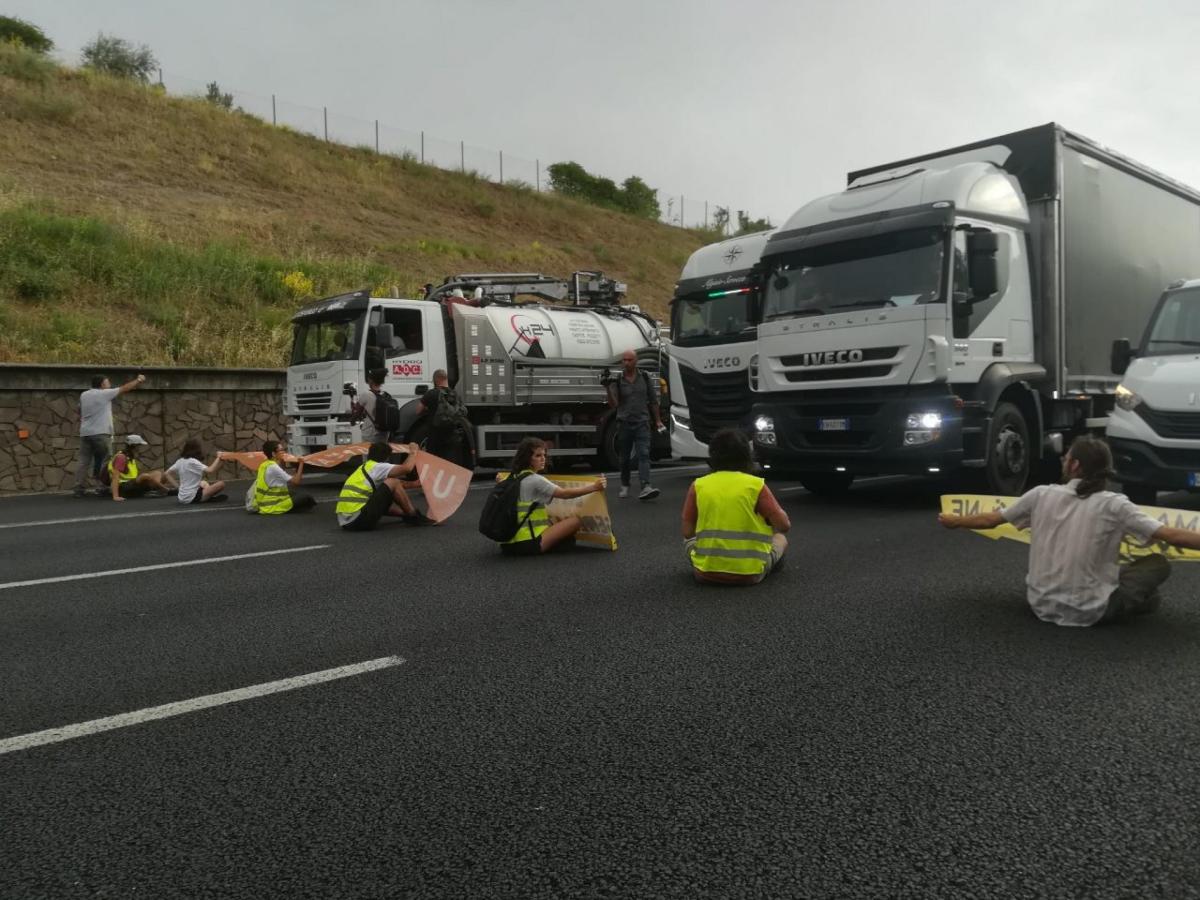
[[763, 228, 946, 319]]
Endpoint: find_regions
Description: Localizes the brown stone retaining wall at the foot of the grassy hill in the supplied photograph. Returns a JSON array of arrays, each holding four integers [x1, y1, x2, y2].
[[0, 365, 287, 494]]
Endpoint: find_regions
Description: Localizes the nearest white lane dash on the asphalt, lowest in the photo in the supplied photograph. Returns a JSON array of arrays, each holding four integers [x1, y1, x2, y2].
[[0, 656, 404, 756]]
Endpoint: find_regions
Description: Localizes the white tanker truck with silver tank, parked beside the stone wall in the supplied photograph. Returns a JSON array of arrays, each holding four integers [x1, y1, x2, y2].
[[284, 272, 671, 468]]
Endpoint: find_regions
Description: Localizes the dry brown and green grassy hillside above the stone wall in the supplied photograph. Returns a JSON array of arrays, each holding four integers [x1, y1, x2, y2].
[[0, 47, 708, 366]]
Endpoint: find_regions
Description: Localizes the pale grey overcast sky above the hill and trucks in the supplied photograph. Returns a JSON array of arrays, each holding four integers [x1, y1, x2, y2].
[[16, 0, 1200, 229]]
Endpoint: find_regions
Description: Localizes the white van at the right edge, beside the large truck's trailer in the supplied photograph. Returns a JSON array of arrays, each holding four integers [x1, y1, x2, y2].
[[1106, 278, 1200, 504]]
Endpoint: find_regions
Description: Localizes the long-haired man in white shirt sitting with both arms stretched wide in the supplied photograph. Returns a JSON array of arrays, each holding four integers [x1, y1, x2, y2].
[[937, 436, 1200, 626]]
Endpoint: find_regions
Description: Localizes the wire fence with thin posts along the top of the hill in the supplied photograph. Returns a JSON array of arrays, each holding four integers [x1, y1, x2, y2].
[[158, 71, 736, 234]]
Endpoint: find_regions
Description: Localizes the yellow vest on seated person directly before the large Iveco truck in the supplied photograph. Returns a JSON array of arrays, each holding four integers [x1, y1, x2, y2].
[[691, 472, 772, 575]]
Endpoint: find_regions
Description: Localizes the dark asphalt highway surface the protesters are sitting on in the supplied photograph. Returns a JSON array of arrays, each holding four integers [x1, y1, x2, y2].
[[0, 470, 1200, 899]]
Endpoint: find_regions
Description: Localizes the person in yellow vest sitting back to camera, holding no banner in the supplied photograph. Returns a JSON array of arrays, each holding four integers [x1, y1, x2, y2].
[[683, 428, 792, 584]]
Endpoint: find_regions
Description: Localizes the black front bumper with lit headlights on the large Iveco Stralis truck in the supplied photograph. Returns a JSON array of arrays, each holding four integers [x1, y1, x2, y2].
[[749, 384, 964, 475]]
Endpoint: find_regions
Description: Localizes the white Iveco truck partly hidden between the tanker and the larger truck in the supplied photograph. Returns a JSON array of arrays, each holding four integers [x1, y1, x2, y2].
[[667, 232, 772, 458]]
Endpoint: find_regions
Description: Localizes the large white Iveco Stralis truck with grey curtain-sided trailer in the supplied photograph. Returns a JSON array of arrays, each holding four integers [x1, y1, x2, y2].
[[749, 124, 1200, 494]]
